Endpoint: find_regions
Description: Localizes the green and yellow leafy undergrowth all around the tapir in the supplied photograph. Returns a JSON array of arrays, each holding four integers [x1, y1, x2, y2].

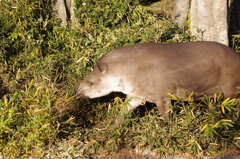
[[0, 0, 240, 158]]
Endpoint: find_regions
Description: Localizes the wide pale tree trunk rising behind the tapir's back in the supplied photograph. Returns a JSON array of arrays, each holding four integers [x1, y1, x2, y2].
[[190, 0, 228, 45]]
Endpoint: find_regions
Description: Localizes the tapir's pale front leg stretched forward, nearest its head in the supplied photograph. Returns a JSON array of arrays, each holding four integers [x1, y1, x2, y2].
[[113, 95, 143, 125]]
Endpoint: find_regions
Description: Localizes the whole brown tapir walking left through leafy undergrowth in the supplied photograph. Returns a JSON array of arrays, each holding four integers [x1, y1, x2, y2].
[[76, 41, 240, 124]]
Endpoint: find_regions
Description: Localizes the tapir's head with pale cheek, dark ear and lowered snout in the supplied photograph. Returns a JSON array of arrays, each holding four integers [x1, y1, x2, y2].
[[76, 63, 117, 98]]
